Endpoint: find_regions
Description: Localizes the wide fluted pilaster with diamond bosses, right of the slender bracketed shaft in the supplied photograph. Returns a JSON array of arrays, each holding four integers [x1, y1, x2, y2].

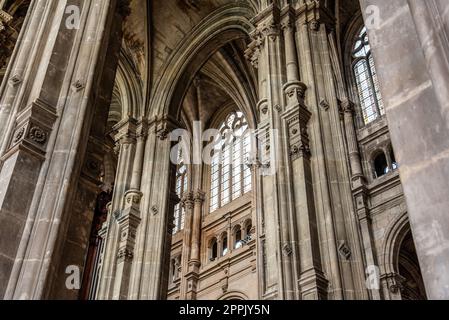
[[296, 1, 367, 299]]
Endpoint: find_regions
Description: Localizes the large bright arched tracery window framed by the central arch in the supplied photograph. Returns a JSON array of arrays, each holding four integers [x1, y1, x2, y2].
[[210, 112, 252, 212]]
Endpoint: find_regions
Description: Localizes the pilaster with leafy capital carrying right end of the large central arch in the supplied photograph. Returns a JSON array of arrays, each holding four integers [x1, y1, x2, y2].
[[246, 4, 298, 299]]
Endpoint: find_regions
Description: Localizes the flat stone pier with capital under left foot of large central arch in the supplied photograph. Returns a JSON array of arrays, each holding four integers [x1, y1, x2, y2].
[[129, 116, 181, 300]]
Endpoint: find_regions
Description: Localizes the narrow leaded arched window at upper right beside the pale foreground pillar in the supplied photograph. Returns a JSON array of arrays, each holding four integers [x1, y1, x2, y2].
[[352, 27, 385, 124]]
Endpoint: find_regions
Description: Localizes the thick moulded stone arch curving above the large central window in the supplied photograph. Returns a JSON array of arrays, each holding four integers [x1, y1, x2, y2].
[[147, 2, 255, 125]]
